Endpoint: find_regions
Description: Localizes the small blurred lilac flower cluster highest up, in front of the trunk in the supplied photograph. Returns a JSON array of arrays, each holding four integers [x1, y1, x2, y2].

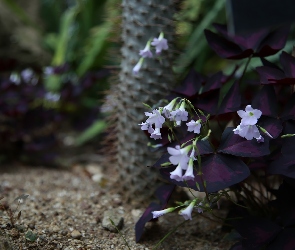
[[133, 32, 169, 75]]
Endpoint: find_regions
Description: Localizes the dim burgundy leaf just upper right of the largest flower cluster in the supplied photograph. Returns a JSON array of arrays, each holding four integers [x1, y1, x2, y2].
[[193, 89, 219, 115]]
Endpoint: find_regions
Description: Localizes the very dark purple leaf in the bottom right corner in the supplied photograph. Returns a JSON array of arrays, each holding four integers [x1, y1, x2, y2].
[[267, 228, 295, 250]]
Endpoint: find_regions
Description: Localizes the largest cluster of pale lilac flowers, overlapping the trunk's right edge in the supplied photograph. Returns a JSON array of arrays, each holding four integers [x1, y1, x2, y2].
[[138, 98, 202, 140]]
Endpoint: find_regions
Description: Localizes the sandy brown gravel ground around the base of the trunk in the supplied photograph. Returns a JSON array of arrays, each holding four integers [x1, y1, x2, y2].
[[0, 163, 236, 250]]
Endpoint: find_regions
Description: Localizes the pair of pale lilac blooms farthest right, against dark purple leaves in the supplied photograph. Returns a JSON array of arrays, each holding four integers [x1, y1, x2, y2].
[[233, 105, 272, 142]]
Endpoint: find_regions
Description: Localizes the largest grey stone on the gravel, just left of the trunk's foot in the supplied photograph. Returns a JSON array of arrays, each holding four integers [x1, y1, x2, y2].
[[102, 209, 124, 233]]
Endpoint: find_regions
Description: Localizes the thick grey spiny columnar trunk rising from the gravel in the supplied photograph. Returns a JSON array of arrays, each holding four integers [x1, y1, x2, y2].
[[113, 0, 175, 201]]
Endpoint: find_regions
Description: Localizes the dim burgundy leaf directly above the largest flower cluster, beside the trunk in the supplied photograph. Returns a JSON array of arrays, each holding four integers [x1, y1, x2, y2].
[[173, 69, 205, 97]]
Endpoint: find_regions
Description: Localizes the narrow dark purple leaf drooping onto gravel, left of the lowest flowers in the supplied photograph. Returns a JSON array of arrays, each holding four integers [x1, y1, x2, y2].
[[135, 202, 165, 242]]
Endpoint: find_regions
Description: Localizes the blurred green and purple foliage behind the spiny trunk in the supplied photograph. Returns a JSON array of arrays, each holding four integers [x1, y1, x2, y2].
[[0, 0, 294, 166]]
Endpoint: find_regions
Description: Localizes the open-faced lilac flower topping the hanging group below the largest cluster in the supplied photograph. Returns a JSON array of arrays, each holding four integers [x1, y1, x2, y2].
[[167, 145, 192, 170]]
